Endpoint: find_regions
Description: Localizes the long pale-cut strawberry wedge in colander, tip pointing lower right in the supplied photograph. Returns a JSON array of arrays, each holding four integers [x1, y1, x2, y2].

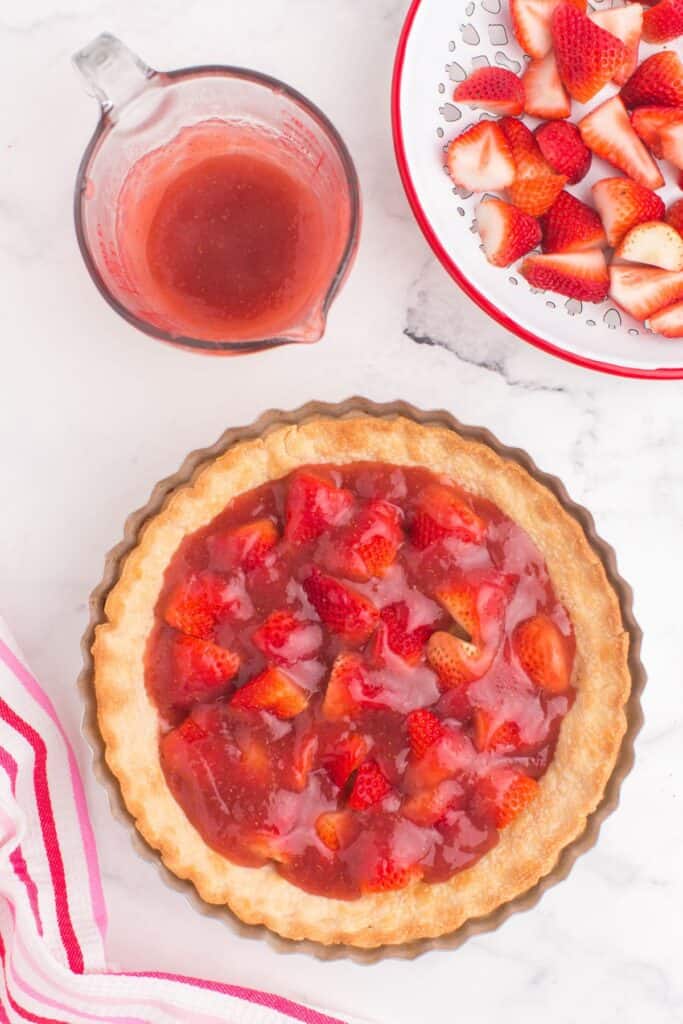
[[579, 97, 664, 188]]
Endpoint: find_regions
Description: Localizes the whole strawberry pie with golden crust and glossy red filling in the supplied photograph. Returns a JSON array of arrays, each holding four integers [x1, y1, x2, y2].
[[94, 417, 630, 947]]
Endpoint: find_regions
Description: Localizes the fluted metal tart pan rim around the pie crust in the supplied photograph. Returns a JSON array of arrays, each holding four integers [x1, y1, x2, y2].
[[78, 397, 646, 964]]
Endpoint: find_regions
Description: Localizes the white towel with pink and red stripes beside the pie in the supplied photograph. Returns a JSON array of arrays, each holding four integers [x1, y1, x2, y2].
[[0, 620, 366, 1024]]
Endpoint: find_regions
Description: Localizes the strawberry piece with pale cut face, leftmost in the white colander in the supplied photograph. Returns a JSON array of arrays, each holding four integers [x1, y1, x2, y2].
[[445, 121, 515, 191]]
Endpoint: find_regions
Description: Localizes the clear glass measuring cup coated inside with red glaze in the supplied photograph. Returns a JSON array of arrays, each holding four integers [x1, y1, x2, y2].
[[74, 34, 360, 354]]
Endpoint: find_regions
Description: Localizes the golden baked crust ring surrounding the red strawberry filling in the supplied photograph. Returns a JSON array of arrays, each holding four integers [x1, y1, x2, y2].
[[93, 416, 631, 948]]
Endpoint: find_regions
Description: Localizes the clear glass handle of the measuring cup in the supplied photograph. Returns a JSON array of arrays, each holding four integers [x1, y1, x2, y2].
[[73, 32, 157, 114]]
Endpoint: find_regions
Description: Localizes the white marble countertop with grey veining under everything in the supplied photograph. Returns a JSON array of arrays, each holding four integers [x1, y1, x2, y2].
[[0, 0, 683, 1024]]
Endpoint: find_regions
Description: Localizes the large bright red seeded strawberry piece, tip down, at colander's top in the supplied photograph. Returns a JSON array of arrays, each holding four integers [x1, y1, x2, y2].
[[551, 3, 629, 103]]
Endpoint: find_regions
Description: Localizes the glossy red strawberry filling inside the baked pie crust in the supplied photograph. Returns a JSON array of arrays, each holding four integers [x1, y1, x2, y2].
[[146, 463, 574, 899]]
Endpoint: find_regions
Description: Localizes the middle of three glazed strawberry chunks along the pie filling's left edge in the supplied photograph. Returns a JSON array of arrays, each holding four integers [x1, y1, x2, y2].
[[173, 635, 240, 707]]
